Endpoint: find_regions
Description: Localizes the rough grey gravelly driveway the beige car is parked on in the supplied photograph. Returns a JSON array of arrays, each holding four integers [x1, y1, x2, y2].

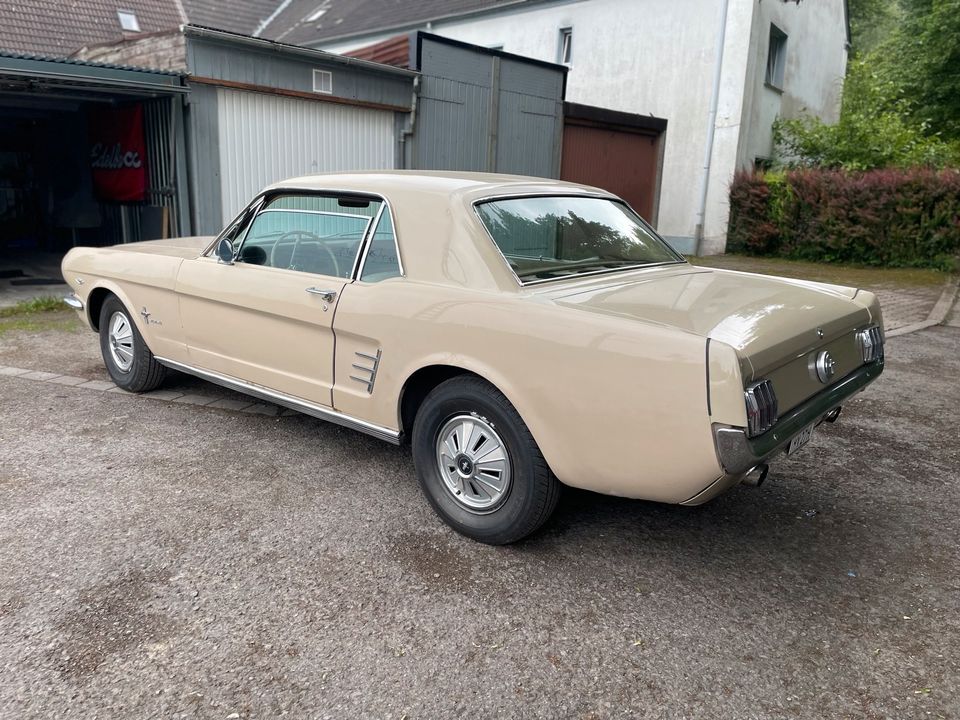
[[0, 320, 960, 720]]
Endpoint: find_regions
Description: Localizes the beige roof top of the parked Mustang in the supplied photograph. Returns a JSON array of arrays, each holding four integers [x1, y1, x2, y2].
[[267, 170, 607, 197]]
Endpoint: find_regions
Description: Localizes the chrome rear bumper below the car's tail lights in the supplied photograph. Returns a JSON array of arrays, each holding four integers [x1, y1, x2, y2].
[[713, 358, 883, 477]]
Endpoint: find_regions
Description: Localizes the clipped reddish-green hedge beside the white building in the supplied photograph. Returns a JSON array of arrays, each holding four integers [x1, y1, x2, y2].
[[727, 168, 960, 270]]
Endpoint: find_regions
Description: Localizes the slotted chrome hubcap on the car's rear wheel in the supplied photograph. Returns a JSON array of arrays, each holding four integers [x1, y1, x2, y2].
[[437, 415, 510, 512]]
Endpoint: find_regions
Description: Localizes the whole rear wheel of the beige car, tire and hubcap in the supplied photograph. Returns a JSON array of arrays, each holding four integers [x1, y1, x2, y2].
[[412, 377, 560, 545]]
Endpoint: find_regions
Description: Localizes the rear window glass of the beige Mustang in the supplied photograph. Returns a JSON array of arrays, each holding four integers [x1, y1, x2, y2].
[[477, 196, 684, 284]]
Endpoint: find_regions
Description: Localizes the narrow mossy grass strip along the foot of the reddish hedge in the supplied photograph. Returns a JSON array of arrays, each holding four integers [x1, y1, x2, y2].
[[687, 255, 949, 288]]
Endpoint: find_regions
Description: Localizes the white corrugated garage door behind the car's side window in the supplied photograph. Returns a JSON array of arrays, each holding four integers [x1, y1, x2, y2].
[[217, 88, 394, 223]]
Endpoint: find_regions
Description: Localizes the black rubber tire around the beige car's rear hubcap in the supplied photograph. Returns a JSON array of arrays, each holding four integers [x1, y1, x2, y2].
[[411, 376, 561, 545]]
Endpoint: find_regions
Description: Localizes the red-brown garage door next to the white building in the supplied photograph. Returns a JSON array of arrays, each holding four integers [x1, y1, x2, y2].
[[560, 104, 666, 224]]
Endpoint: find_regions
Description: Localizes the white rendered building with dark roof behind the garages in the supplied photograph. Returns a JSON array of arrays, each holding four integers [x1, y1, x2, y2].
[[274, 0, 848, 254]]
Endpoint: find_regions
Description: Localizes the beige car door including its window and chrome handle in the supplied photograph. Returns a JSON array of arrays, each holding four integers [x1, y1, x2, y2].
[[177, 192, 381, 406]]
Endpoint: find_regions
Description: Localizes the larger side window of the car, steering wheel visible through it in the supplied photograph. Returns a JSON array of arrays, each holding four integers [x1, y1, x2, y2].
[[237, 194, 382, 278]]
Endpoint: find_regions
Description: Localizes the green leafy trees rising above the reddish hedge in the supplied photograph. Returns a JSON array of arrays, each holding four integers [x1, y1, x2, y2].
[[774, 0, 960, 170]]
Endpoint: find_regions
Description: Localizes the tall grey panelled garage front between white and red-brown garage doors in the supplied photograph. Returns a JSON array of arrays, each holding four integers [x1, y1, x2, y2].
[[411, 37, 564, 177]]
